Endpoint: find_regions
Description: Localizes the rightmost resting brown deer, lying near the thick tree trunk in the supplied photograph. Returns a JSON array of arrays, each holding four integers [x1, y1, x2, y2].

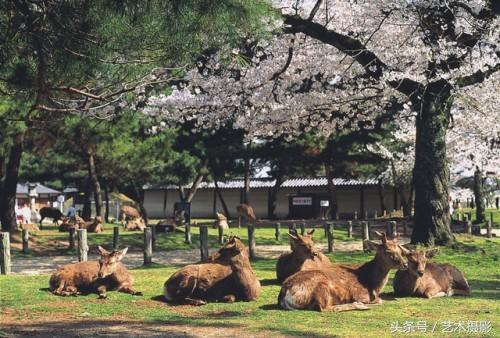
[[393, 249, 470, 298]]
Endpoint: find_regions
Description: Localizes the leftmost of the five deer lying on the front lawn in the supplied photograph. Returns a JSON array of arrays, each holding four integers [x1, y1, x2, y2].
[[49, 247, 142, 299]]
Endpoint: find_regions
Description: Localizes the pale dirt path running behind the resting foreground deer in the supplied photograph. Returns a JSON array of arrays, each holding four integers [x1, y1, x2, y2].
[[8, 241, 372, 275]]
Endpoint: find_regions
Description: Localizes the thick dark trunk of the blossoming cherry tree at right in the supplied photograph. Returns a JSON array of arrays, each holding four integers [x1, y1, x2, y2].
[[411, 80, 454, 245]]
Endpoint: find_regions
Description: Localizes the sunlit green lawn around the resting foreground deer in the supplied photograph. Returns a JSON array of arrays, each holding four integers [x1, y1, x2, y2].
[[0, 236, 500, 337]]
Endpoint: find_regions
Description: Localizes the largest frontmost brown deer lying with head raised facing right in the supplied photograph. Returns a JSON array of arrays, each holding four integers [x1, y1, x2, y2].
[[278, 232, 408, 311]]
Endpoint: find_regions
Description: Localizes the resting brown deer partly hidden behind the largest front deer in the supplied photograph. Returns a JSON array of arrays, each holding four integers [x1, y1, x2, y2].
[[276, 229, 332, 283]]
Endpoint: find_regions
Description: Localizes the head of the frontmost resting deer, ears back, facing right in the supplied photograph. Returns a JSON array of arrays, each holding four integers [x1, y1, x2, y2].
[[364, 231, 409, 269]]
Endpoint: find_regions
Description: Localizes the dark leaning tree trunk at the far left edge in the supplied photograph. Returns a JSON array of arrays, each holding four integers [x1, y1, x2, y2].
[[0, 133, 24, 232]]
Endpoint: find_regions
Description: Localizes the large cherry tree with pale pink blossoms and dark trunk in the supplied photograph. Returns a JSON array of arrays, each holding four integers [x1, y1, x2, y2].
[[146, 0, 500, 244]]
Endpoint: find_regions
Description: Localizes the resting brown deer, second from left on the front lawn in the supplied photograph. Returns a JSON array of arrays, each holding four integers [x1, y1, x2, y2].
[[164, 237, 260, 305]]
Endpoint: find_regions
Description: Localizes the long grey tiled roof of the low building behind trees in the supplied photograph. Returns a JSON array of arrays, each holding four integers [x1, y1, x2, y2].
[[144, 177, 377, 190]]
